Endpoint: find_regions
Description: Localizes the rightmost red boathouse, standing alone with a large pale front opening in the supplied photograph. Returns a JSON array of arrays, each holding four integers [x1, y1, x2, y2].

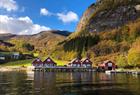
[[98, 60, 117, 70]]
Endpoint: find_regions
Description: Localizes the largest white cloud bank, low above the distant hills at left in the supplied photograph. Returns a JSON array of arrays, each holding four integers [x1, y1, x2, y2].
[[0, 15, 50, 34]]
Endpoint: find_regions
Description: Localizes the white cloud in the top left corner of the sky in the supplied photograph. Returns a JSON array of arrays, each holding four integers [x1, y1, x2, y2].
[[0, 0, 18, 12]]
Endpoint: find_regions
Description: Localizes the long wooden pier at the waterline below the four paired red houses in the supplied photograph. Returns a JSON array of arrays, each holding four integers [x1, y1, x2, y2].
[[33, 67, 95, 72]]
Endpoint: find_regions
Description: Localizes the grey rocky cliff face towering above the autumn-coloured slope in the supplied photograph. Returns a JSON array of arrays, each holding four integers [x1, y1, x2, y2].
[[76, 0, 140, 32]]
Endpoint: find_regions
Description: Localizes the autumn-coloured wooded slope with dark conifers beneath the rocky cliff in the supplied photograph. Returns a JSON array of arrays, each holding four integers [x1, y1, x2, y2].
[[52, 19, 140, 66]]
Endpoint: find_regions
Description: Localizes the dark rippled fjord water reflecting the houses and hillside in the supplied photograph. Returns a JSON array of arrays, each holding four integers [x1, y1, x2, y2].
[[0, 72, 140, 95]]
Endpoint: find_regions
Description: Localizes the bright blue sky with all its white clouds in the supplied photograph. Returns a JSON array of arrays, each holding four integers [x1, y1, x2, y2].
[[0, 0, 95, 34]]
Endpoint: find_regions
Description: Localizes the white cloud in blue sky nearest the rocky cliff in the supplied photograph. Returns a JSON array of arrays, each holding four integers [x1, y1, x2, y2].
[[57, 11, 79, 23]]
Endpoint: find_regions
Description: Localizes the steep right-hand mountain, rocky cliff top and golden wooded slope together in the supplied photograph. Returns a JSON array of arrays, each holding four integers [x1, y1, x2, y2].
[[52, 0, 140, 67]]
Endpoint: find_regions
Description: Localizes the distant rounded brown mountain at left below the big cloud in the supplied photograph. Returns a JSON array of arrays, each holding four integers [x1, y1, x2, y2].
[[0, 30, 70, 54]]
